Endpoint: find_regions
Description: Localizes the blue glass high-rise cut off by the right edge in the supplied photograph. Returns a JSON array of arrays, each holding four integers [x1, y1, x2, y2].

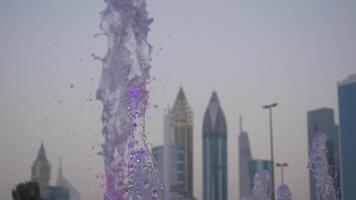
[[338, 74, 356, 200]]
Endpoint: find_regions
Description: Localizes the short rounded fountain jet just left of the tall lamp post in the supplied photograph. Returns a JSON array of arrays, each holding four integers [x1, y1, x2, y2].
[[251, 170, 271, 200]]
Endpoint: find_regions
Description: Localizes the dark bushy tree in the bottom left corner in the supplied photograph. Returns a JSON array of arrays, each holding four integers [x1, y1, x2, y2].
[[12, 181, 42, 200]]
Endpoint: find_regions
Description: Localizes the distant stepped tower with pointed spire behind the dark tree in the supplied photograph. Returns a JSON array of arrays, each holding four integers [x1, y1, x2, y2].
[[31, 143, 51, 194]]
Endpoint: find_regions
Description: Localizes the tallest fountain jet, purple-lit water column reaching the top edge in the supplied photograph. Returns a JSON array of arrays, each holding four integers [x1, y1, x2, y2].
[[93, 0, 163, 200]]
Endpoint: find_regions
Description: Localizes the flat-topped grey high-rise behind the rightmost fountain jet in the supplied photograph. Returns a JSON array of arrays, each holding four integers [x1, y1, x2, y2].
[[307, 108, 340, 200]]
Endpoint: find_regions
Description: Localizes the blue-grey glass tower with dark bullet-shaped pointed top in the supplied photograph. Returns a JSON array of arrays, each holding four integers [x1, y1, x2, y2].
[[203, 92, 228, 200]]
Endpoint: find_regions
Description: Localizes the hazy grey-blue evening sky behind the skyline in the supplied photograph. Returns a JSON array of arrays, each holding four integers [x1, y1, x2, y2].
[[0, 0, 356, 200]]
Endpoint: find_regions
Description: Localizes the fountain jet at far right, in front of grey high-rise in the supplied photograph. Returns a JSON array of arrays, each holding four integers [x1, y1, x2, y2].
[[308, 131, 337, 200]]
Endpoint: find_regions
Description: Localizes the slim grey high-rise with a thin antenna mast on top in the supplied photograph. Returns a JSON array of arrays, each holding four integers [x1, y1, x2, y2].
[[239, 116, 252, 199]]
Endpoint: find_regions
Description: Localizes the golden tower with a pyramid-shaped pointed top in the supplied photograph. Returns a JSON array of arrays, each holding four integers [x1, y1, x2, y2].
[[172, 87, 193, 199]]
